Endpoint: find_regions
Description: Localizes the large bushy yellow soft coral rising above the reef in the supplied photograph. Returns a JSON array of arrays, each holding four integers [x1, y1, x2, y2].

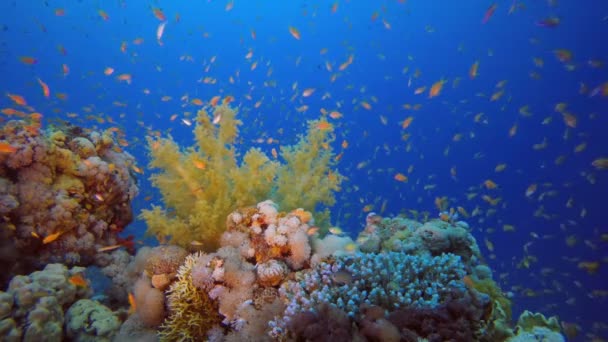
[[142, 105, 343, 251]]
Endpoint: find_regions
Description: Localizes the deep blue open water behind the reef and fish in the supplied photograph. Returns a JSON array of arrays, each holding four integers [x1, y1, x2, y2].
[[0, 0, 608, 338]]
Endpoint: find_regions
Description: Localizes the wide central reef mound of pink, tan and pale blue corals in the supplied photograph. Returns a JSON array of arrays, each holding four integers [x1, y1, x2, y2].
[[64, 200, 563, 342]]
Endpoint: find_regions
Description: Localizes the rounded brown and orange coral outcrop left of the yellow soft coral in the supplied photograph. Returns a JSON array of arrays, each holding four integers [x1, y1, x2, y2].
[[0, 120, 138, 276]]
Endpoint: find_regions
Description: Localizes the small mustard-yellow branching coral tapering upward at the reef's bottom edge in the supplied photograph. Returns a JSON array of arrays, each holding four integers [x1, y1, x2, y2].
[[158, 254, 221, 341]]
